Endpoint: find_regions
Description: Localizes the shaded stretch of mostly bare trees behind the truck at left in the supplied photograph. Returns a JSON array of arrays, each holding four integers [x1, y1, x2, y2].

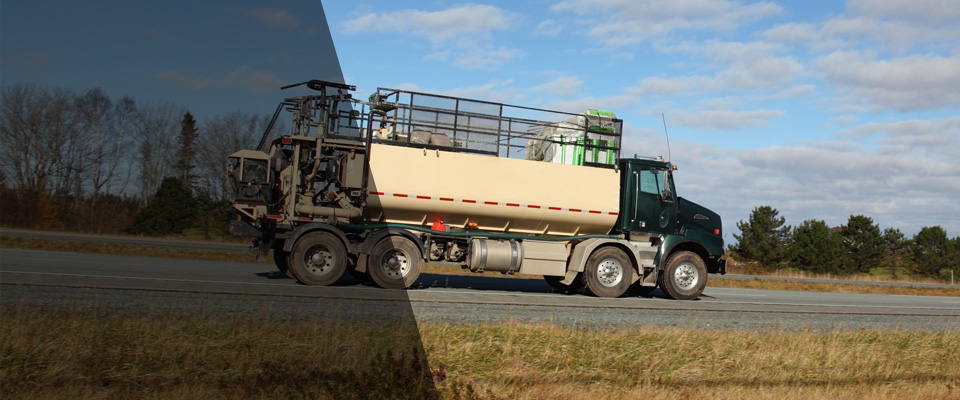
[[0, 83, 285, 235]]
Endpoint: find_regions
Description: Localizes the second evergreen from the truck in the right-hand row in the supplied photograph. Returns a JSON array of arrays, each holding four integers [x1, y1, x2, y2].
[[790, 220, 843, 273]]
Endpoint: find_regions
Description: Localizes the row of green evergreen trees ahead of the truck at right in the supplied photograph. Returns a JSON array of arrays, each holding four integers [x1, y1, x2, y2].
[[728, 206, 960, 279]]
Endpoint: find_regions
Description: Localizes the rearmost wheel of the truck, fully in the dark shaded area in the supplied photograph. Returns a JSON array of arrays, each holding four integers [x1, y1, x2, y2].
[[289, 232, 347, 286]]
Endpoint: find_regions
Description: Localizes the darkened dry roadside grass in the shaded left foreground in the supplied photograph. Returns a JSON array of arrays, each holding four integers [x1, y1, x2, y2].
[[0, 304, 435, 399]]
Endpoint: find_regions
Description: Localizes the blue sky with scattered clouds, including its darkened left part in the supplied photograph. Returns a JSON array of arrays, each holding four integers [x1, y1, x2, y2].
[[0, 0, 960, 239]]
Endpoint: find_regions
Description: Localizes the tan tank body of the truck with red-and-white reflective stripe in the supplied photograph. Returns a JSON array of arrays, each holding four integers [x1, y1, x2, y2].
[[363, 143, 620, 236]]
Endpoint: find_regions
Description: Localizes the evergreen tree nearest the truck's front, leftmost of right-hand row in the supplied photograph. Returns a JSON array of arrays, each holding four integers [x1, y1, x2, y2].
[[733, 206, 790, 268]]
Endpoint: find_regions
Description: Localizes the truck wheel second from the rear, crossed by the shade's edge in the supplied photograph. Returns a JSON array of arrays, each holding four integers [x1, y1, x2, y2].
[[367, 236, 423, 289]]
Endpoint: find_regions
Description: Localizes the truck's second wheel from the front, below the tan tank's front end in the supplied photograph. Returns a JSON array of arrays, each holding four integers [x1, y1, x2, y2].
[[583, 247, 634, 297]]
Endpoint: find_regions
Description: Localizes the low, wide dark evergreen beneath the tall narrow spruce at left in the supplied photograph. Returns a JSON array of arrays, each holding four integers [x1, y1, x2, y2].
[[127, 177, 200, 236]]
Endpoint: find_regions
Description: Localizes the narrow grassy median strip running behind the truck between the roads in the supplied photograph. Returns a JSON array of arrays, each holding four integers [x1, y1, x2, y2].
[[0, 237, 960, 297]]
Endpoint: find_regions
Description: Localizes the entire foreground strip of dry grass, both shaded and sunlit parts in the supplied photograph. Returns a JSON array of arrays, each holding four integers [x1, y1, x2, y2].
[[0, 303, 960, 400]]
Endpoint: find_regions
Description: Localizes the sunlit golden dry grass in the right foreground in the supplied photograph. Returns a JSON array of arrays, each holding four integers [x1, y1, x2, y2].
[[421, 324, 960, 399]]
